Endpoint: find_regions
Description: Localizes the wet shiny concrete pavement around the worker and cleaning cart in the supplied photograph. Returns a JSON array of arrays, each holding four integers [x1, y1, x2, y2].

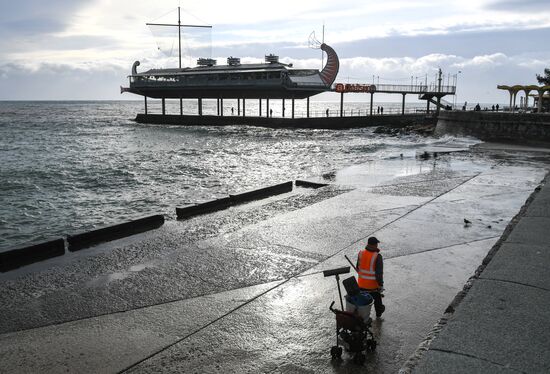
[[0, 142, 549, 373]]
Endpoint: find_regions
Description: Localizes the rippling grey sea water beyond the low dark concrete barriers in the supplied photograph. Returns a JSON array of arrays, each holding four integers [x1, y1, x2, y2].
[[0, 101, 478, 251]]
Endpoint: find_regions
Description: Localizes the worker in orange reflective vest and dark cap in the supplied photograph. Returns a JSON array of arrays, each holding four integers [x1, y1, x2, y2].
[[357, 236, 386, 318]]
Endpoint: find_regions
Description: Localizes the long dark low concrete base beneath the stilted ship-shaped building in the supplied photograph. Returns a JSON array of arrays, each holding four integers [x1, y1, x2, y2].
[[136, 113, 435, 130]]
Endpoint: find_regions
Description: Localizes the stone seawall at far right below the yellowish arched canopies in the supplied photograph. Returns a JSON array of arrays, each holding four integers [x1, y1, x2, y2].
[[435, 111, 550, 144]]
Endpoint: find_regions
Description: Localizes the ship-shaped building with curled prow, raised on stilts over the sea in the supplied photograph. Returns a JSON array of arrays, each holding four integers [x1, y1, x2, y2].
[[122, 43, 339, 99]]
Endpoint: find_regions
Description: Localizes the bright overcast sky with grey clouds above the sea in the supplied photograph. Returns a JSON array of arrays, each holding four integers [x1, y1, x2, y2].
[[0, 0, 550, 103]]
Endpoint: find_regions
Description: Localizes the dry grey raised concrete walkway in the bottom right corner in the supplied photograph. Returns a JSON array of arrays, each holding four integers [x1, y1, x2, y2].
[[402, 170, 550, 374]]
